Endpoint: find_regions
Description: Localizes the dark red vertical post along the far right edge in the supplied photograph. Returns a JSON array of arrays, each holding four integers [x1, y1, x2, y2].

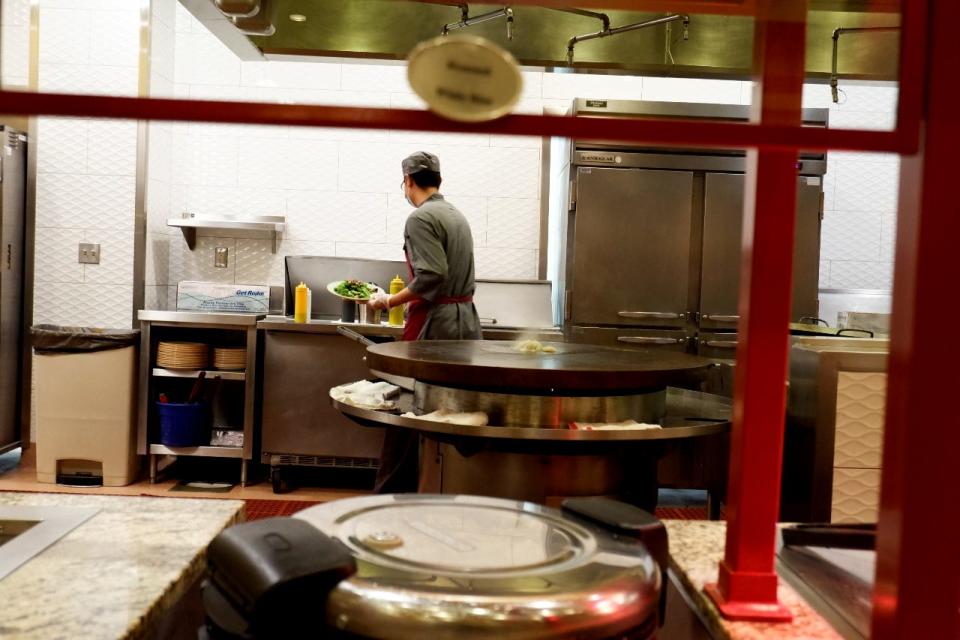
[[872, 0, 960, 640]]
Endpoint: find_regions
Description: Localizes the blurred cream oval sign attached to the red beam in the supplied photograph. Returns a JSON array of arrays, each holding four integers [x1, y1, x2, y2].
[[407, 35, 523, 122]]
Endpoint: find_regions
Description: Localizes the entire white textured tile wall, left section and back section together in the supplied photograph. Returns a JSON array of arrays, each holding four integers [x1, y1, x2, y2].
[[24, 0, 898, 324]]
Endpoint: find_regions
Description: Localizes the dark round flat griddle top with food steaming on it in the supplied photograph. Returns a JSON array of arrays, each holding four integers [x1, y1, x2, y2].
[[367, 340, 711, 393]]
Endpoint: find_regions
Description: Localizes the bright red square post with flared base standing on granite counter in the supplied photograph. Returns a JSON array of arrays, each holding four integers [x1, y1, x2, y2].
[[707, 0, 807, 621]]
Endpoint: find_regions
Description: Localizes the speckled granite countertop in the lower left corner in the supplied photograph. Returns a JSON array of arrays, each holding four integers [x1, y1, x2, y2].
[[0, 492, 243, 640]]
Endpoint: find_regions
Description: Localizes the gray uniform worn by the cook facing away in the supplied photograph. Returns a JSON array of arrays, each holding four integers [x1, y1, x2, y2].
[[403, 193, 482, 340]]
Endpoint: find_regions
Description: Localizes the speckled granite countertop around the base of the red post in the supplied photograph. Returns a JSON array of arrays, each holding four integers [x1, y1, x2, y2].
[[664, 520, 841, 640]]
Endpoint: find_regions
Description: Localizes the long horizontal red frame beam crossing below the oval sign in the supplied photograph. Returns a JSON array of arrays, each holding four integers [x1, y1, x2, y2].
[[0, 89, 916, 153]]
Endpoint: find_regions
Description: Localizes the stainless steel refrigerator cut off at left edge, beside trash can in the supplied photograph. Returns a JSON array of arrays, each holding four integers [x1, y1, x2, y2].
[[0, 125, 27, 452]]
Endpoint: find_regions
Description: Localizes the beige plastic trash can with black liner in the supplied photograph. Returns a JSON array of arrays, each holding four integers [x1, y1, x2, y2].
[[32, 325, 140, 487]]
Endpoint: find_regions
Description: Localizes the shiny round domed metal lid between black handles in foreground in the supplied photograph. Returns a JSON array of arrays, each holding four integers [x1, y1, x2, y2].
[[296, 495, 660, 640]]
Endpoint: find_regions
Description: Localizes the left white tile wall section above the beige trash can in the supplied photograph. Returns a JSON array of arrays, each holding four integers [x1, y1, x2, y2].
[[34, 0, 141, 327]]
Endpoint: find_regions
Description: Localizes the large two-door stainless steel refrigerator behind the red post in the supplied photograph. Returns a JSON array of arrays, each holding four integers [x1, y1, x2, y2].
[[552, 100, 827, 359]]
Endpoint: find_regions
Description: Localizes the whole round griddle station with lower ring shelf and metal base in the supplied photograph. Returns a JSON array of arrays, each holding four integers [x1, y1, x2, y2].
[[332, 341, 730, 509]]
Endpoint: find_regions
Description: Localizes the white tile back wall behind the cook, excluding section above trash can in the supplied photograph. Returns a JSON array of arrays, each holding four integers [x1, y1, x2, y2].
[[150, 12, 898, 288]]
